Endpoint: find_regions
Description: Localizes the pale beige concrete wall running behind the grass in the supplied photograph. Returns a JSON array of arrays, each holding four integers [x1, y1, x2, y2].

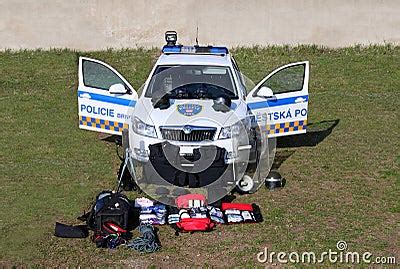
[[0, 0, 400, 50]]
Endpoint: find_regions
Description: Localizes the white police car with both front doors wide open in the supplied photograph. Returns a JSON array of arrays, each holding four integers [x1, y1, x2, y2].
[[78, 33, 309, 195]]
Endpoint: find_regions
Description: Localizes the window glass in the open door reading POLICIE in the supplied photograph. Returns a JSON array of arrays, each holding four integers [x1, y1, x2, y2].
[[82, 60, 125, 90]]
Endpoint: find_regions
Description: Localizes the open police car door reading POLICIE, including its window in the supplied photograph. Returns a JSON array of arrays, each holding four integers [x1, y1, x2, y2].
[[78, 57, 138, 135]]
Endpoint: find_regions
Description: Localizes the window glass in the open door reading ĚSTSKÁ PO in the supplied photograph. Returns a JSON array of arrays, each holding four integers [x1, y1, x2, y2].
[[260, 64, 306, 94]]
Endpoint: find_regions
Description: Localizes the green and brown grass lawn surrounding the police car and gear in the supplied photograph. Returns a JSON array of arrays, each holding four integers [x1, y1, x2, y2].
[[0, 46, 400, 267]]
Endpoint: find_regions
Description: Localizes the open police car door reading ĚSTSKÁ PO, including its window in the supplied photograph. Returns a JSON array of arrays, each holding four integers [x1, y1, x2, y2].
[[247, 61, 310, 137]]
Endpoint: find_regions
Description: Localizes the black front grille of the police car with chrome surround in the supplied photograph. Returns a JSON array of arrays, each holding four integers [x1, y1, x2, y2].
[[160, 126, 217, 142]]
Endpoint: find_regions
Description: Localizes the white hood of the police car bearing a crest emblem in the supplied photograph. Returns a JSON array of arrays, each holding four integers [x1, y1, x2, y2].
[[143, 98, 243, 127]]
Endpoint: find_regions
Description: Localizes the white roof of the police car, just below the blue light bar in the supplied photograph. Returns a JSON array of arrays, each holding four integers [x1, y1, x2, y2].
[[156, 53, 232, 66]]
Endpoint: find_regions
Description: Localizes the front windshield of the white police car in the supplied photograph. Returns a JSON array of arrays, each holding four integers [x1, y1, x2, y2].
[[145, 65, 238, 99]]
